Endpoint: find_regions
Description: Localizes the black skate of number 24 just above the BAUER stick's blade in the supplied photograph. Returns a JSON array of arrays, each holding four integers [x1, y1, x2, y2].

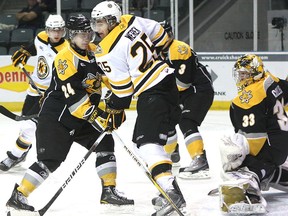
[[6, 184, 34, 211]]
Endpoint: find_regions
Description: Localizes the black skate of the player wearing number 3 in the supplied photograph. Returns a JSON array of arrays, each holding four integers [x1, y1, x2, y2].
[[178, 151, 210, 179]]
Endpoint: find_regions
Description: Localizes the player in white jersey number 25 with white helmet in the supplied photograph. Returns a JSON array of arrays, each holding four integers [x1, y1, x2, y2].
[[91, 1, 186, 216]]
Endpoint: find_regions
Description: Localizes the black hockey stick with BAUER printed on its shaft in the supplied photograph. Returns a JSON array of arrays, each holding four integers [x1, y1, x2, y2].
[[7, 127, 109, 216]]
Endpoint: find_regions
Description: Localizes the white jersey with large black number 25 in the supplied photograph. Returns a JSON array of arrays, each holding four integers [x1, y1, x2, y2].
[[95, 15, 173, 101]]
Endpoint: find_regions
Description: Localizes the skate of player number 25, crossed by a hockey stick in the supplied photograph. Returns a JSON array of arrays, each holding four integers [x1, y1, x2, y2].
[[152, 180, 186, 216]]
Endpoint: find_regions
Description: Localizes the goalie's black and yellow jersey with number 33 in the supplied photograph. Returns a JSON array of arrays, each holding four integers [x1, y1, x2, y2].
[[230, 72, 288, 155]]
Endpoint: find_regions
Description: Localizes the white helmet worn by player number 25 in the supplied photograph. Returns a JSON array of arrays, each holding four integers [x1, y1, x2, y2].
[[91, 1, 122, 31]]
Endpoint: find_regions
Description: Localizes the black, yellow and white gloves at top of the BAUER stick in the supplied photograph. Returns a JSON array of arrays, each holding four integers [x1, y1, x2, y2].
[[88, 107, 126, 131]]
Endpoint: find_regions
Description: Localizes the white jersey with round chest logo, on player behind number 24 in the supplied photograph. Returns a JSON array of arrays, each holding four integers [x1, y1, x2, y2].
[[27, 31, 68, 96]]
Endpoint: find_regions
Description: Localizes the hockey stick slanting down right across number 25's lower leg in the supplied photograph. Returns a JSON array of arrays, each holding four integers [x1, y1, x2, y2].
[[112, 131, 184, 216]]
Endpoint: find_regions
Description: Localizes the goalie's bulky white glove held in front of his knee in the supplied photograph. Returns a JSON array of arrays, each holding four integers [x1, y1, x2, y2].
[[220, 133, 250, 171]]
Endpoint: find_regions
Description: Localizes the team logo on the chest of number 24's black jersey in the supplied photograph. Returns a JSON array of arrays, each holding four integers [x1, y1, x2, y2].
[[82, 73, 101, 94]]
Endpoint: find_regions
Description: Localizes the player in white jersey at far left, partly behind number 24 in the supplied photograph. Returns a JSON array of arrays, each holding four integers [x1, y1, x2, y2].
[[0, 15, 68, 171]]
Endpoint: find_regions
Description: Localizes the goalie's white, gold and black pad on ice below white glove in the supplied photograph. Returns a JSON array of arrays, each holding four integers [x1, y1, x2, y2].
[[219, 169, 267, 215]]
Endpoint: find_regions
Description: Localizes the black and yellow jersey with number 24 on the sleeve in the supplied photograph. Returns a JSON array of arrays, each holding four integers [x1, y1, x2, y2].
[[40, 43, 101, 128]]
